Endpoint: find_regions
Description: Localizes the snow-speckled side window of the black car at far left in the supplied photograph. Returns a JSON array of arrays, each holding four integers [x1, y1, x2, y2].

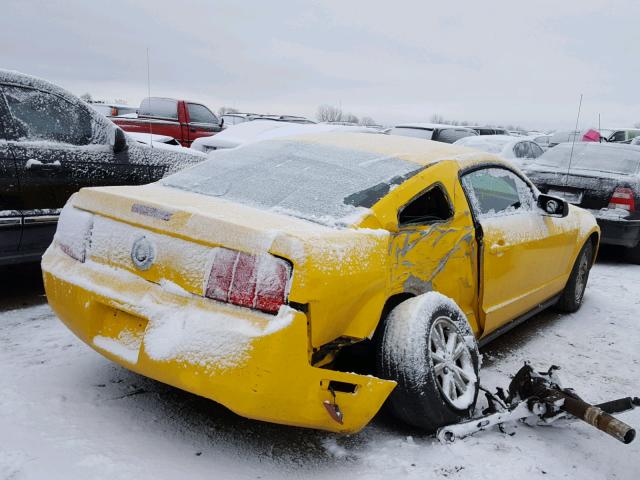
[[2, 85, 92, 145]]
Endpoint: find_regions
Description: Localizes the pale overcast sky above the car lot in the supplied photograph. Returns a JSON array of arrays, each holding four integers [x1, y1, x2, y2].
[[0, 0, 640, 129]]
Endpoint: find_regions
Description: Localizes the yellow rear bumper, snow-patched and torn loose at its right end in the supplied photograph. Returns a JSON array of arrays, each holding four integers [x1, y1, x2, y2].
[[42, 246, 395, 433]]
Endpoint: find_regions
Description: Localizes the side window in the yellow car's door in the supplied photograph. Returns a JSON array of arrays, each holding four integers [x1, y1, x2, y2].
[[462, 168, 535, 217]]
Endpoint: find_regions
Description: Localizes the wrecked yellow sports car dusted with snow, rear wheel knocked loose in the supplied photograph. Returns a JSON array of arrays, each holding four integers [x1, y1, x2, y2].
[[42, 133, 599, 432]]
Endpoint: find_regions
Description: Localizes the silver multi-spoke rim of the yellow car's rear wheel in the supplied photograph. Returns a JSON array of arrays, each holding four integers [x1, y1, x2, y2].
[[429, 317, 476, 408]]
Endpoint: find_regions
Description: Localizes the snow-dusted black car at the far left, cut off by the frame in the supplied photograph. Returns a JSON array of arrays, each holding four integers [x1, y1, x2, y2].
[[0, 70, 202, 265]]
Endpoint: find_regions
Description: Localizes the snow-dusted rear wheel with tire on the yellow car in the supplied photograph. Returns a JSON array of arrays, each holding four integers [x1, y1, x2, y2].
[[377, 292, 479, 433]]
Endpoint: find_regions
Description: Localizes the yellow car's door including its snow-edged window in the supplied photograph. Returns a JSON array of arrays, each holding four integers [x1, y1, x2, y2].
[[462, 167, 578, 336]]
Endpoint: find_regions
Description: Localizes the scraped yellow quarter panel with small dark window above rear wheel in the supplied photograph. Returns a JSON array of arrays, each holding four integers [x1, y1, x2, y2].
[[389, 162, 478, 333]]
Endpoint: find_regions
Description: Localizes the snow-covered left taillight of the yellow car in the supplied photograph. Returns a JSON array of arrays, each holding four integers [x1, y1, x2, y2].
[[53, 204, 93, 262]]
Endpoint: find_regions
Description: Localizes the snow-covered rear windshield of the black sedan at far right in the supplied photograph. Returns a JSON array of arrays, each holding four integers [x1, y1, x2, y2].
[[535, 142, 640, 175]]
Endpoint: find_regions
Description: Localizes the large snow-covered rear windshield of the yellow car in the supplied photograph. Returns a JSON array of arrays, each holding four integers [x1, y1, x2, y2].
[[161, 140, 424, 225]]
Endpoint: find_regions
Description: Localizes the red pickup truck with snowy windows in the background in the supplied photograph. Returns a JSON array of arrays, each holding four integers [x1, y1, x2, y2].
[[111, 97, 222, 147]]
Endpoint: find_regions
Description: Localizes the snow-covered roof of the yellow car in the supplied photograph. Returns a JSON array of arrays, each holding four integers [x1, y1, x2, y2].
[[272, 132, 512, 168]]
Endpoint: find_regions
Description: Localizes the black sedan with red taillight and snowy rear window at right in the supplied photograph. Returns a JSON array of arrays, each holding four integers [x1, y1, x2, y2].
[[526, 142, 640, 263]]
